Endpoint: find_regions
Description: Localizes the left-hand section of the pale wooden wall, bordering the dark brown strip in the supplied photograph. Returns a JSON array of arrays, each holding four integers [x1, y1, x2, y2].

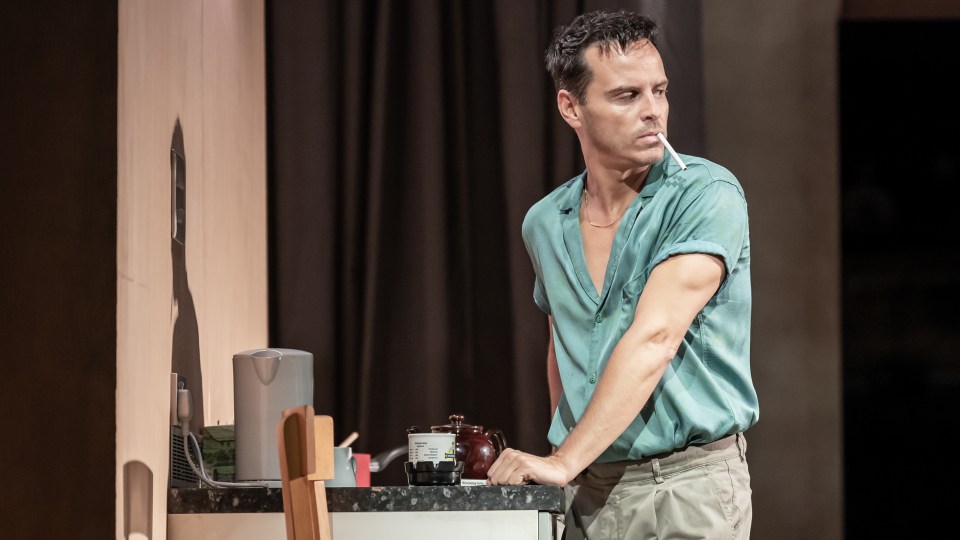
[[116, 0, 203, 538]]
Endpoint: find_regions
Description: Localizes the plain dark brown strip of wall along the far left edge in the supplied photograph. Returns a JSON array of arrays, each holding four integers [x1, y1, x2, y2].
[[0, 1, 117, 538]]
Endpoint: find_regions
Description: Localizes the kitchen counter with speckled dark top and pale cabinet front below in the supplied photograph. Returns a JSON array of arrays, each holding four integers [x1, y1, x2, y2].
[[167, 486, 564, 540]]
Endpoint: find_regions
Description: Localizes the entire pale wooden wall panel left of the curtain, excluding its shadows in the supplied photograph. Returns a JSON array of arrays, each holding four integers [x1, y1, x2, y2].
[[116, 0, 267, 538]]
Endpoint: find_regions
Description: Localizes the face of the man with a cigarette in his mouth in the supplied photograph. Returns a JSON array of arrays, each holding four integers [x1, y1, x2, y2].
[[574, 41, 670, 170]]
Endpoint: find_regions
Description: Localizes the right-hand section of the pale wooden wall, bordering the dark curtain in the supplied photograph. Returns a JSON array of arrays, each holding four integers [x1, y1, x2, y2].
[[197, 0, 268, 424]]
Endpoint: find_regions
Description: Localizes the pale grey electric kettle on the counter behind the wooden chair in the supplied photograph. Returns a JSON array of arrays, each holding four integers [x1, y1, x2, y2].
[[233, 349, 313, 482]]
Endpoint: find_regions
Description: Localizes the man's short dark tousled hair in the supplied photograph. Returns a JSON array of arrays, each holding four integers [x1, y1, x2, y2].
[[546, 10, 658, 103]]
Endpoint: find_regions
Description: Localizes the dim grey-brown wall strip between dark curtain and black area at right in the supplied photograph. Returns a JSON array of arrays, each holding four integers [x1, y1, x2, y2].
[[703, 0, 842, 539]]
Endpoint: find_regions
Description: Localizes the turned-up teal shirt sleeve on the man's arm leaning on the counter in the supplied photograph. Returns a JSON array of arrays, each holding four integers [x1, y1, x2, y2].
[[650, 180, 748, 277]]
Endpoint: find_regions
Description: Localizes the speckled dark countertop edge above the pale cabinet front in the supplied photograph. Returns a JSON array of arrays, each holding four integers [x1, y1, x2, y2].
[[167, 486, 563, 514]]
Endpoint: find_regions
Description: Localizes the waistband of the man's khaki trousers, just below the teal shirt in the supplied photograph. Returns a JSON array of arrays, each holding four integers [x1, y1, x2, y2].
[[576, 433, 747, 485]]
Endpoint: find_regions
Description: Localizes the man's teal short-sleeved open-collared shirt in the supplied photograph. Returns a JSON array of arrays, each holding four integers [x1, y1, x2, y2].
[[523, 153, 759, 462]]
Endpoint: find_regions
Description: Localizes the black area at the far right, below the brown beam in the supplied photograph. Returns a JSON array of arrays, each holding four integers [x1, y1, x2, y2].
[[840, 19, 960, 538]]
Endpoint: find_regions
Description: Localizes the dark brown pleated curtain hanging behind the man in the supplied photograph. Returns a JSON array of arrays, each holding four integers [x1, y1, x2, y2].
[[267, 0, 703, 485]]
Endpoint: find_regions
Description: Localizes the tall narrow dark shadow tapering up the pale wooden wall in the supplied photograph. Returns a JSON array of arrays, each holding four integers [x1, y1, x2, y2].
[[170, 118, 203, 433]]
